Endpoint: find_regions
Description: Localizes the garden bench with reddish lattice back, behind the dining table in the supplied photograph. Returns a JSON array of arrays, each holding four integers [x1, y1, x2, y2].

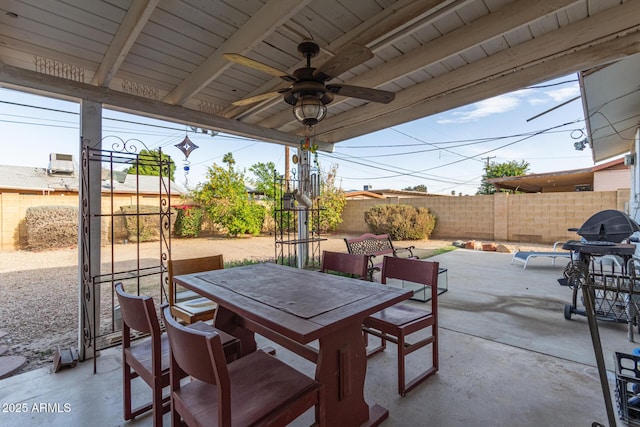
[[344, 233, 418, 281]]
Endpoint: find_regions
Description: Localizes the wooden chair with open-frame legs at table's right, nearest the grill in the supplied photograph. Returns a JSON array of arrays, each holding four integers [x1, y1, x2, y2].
[[364, 257, 439, 396]]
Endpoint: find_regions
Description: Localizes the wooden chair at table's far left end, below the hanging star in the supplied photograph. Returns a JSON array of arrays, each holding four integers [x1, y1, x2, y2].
[[169, 254, 224, 324]]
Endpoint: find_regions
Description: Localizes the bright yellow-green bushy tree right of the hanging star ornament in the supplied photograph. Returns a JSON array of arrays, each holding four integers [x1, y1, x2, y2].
[[193, 153, 264, 236]]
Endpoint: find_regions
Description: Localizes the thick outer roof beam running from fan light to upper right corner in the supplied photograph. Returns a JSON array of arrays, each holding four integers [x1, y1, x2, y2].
[[318, 2, 640, 143]]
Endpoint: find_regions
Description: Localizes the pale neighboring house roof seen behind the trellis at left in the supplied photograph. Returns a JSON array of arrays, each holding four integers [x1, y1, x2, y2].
[[0, 165, 187, 194]]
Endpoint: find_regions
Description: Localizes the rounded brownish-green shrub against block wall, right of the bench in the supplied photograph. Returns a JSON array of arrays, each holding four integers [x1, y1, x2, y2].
[[364, 205, 436, 240]]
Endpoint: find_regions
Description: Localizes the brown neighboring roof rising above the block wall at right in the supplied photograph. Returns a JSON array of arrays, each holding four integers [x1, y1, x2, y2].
[[487, 158, 629, 193]]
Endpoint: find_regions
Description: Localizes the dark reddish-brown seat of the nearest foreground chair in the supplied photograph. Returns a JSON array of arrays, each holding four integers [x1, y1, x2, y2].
[[174, 350, 318, 426]]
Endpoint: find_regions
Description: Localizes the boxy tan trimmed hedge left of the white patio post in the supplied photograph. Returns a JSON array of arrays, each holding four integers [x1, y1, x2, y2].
[[25, 206, 78, 251]]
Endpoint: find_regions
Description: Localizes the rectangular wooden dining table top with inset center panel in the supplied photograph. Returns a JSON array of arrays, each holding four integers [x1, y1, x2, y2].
[[174, 263, 413, 344]]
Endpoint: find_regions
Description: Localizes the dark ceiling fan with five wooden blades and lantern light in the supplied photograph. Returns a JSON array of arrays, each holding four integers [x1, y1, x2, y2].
[[224, 40, 395, 126]]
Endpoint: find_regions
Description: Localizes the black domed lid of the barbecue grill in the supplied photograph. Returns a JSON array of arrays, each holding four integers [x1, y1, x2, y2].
[[578, 209, 640, 243]]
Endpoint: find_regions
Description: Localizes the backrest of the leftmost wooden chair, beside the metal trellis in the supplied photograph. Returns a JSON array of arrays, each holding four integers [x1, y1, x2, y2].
[[114, 282, 160, 337]]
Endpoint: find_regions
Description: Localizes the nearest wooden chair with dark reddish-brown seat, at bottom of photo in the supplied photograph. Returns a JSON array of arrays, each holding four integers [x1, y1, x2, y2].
[[162, 304, 324, 426]]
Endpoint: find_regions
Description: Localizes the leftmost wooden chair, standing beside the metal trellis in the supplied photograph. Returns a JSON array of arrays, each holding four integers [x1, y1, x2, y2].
[[114, 283, 240, 427]]
